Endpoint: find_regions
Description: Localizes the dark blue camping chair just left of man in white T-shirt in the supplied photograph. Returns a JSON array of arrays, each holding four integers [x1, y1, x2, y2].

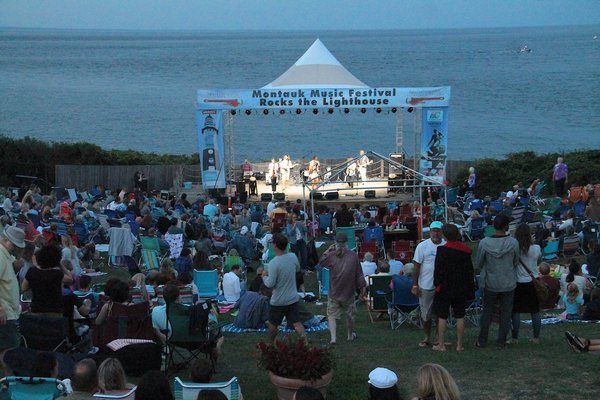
[[388, 275, 421, 329]]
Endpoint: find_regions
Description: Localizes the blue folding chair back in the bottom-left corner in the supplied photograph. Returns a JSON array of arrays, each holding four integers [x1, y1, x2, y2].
[[0, 376, 67, 400]]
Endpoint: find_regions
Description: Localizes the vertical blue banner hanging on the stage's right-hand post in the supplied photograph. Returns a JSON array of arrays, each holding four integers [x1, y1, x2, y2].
[[419, 107, 448, 183]]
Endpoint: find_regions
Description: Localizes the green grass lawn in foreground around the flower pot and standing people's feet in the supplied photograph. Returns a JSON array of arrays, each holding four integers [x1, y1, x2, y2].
[[89, 248, 600, 400]]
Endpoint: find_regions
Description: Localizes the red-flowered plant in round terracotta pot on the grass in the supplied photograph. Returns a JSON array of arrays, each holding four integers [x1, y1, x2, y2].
[[257, 337, 335, 400]]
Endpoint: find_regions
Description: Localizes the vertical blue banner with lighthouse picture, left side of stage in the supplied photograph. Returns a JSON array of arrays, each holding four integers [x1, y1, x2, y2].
[[196, 110, 226, 190]]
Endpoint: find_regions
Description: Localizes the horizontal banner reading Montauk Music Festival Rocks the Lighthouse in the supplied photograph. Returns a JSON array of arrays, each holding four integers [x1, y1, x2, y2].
[[197, 86, 450, 110]]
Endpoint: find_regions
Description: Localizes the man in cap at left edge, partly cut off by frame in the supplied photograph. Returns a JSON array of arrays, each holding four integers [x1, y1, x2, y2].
[[0, 226, 25, 374]]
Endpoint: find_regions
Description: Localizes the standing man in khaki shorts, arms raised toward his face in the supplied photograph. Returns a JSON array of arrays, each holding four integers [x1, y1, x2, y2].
[[319, 233, 367, 344]]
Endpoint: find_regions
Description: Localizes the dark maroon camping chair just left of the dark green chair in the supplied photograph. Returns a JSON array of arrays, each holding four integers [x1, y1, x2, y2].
[[92, 301, 155, 351]]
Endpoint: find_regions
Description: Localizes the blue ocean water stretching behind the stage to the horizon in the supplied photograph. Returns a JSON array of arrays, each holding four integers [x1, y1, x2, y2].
[[0, 26, 600, 160]]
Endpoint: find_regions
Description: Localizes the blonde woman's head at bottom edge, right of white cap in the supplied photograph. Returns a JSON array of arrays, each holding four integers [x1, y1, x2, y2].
[[413, 364, 460, 400]]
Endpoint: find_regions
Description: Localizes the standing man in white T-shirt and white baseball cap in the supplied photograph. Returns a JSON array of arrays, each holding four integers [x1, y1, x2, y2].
[[412, 221, 446, 347]]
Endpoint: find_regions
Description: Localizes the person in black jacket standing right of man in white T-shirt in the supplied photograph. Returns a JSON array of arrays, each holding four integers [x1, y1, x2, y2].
[[433, 224, 475, 351]]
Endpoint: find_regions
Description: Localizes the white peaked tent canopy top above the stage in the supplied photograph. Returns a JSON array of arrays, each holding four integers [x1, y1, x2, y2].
[[263, 39, 368, 89]]
